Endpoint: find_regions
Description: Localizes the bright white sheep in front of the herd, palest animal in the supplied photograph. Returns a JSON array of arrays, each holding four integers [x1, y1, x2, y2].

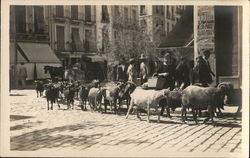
[[126, 87, 169, 122]]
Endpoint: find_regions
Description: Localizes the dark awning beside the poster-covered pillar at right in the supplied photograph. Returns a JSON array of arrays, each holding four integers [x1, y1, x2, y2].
[[159, 6, 194, 48]]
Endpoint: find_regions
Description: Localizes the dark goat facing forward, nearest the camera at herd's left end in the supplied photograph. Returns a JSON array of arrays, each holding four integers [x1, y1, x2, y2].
[[45, 83, 60, 110]]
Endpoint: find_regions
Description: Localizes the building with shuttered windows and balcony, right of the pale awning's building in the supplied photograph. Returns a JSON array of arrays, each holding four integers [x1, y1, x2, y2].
[[49, 5, 96, 66]]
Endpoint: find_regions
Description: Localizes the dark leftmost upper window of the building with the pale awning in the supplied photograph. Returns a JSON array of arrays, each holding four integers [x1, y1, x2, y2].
[[15, 6, 26, 33]]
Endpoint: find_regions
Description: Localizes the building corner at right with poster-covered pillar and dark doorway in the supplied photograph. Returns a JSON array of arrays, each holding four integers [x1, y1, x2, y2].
[[194, 6, 242, 89]]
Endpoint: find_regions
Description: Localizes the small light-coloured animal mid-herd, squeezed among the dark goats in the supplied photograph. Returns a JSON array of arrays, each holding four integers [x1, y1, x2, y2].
[[88, 88, 104, 110]]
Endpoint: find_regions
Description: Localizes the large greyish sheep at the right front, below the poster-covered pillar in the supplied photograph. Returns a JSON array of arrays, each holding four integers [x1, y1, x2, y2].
[[181, 83, 231, 125]]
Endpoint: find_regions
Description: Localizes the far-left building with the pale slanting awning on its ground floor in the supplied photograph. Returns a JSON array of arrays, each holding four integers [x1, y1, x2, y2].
[[10, 6, 61, 80]]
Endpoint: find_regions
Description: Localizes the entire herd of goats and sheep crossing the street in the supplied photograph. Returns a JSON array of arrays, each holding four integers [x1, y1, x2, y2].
[[35, 80, 232, 124]]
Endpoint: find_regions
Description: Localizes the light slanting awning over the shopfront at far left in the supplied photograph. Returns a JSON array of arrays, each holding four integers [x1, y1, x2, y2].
[[17, 43, 61, 63]]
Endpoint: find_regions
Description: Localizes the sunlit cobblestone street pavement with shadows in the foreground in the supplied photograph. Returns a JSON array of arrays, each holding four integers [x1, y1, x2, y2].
[[10, 90, 242, 154]]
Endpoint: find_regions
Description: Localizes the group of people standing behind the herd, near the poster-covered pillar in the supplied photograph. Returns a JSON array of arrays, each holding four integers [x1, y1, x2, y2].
[[116, 50, 215, 90]]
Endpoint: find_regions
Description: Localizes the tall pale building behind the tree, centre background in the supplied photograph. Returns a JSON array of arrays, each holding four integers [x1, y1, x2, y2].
[[96, 5, 138, 62]]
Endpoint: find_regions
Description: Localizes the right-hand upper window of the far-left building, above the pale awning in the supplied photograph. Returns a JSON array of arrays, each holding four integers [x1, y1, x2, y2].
[[34, 6, 45, 33]]
